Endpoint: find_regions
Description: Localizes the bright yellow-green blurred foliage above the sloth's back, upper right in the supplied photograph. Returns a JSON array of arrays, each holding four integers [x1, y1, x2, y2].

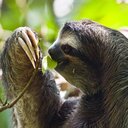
[[72, 0, 128, 29]]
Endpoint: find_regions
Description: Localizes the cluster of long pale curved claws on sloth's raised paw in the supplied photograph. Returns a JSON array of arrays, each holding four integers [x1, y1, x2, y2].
[[17, 27, 39, 68]]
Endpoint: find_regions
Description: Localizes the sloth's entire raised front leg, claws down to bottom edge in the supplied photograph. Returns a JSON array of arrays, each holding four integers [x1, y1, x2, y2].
[[1, 27, 60, 128]]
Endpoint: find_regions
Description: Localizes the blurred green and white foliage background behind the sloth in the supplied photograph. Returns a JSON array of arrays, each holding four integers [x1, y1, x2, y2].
[[0, 0, 128, 128]]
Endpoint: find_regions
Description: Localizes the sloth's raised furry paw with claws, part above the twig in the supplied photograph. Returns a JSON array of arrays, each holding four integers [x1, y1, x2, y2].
[[1, 27, 41, 92]]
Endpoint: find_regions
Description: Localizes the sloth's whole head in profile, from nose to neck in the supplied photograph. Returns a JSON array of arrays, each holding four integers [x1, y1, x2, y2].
[[48, 20, 126, 93]]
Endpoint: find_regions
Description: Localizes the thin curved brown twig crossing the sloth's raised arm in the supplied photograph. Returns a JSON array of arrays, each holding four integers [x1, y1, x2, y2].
[[0, 64, 38, 112]]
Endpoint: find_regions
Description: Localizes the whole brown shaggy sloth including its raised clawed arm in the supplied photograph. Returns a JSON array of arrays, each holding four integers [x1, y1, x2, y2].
[[1, 20, 128, 128]]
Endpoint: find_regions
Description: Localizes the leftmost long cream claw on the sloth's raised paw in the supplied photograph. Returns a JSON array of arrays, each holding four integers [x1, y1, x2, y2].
[[18, 37, 36, 69]]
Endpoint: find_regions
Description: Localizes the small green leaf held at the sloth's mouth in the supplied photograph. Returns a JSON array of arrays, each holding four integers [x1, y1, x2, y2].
[[42, 56, 57, 73]]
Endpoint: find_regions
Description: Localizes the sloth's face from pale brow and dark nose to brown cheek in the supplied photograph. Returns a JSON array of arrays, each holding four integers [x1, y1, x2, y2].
[[48, 31, 97, 92]]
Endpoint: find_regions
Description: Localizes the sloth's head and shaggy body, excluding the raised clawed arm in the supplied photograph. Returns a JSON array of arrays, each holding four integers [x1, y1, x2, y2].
[[48, 20, 128, 128]]
